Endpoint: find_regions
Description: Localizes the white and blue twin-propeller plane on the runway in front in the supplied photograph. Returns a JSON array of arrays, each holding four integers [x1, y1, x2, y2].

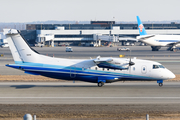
[[6, 29, 175, 87]]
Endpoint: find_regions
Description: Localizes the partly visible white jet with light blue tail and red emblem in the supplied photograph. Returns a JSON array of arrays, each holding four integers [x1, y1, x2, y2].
[[136, 16, 180, 51]]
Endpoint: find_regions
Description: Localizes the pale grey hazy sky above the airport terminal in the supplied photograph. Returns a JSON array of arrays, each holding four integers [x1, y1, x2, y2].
[[0, 0, 180, 23]]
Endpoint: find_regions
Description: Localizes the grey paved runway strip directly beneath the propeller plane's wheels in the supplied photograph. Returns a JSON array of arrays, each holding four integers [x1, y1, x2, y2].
[[0, 82, 180, 104]]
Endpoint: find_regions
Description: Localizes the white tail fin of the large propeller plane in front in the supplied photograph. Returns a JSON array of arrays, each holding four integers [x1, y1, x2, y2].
[[6, 29, 39, 64]]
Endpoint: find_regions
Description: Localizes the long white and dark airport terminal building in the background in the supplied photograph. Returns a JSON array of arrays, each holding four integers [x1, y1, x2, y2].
[[21, 21, 180, 46]]
